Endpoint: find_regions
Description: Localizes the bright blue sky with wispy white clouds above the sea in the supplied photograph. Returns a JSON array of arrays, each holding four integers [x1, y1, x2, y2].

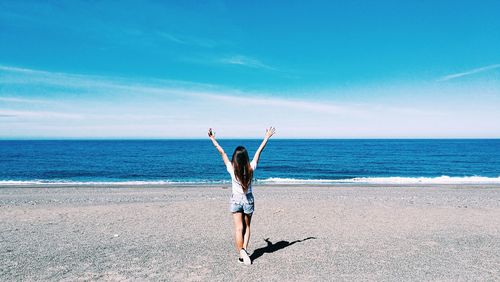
[[0, 0, 500, 138]]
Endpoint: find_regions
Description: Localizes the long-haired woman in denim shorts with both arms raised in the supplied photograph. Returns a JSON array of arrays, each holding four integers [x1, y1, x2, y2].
[[208, 127, 276, 265]]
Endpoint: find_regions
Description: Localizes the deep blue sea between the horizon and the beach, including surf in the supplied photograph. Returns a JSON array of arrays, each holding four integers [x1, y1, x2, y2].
[[0, 139, 500, 185]]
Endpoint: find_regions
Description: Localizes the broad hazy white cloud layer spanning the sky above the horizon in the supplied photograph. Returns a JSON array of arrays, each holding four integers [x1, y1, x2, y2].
[[0, 66, 500, 138]]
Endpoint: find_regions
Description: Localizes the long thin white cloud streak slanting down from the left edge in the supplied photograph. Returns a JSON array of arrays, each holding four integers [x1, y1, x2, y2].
[[0, 62, 352, 114]]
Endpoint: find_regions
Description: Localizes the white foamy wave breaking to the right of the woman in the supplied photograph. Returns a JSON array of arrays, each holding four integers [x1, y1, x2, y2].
[[258, 175, 500, 184]]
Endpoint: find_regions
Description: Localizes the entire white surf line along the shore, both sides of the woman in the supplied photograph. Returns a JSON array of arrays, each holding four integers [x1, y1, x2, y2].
[[0, 175, 500, 186]]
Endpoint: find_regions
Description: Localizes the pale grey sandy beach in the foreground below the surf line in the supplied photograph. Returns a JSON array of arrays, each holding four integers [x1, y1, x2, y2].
[[0, 185, 500, 281]]
